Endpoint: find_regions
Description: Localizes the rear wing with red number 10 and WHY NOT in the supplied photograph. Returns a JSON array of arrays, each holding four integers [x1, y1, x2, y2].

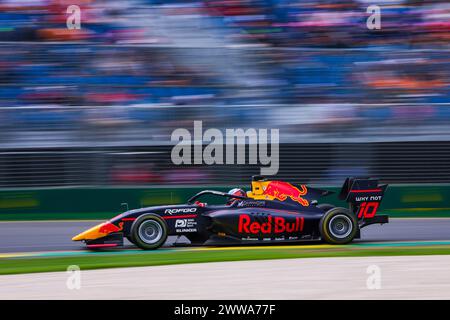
[[339, 177, 388, 224]]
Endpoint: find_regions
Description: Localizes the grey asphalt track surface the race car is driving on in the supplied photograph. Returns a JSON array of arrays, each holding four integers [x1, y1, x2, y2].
[[0, 218, 450, 253]]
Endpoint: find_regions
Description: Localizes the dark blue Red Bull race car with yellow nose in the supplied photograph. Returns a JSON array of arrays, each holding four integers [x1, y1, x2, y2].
[[72, 176, 389, 250]]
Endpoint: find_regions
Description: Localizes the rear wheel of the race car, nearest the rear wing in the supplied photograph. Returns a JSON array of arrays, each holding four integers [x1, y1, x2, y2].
[[319, 208, 358, 244]]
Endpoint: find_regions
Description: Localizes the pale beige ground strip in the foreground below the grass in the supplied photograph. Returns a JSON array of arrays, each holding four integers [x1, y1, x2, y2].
[[0, 255, 450, 300]]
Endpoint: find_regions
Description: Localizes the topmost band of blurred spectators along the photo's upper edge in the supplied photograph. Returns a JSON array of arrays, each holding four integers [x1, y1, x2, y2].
[[0, 0, 450, 47]]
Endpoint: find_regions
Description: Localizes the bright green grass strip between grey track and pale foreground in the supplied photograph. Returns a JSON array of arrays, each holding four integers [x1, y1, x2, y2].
[[0, 245, 450, 274]]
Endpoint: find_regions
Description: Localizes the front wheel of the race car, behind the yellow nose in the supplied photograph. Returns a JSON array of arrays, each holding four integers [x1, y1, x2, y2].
[[131, 214, 168, 250]]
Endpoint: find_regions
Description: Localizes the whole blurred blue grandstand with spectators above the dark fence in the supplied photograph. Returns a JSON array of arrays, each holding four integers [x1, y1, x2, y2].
[[0, 0, 450, 136]]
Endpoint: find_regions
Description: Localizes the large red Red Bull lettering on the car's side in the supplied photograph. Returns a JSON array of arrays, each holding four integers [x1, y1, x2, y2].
[[238, 214, 305, 234]]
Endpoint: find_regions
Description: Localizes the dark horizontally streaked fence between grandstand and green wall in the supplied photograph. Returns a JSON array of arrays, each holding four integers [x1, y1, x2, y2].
[[0, 141, 450, 189]]
